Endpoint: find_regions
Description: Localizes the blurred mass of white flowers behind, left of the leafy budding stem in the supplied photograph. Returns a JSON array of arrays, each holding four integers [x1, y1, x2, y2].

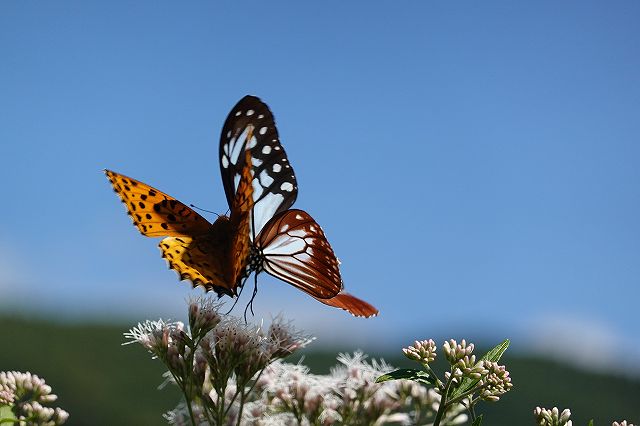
[[179, 352, 467, 426]]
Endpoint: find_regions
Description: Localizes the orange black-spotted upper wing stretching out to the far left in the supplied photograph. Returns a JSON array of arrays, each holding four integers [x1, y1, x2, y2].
[[104, 170, 211, 237]]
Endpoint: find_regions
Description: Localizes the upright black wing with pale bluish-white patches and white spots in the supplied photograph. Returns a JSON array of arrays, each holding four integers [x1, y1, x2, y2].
[[220, 96, 298, 238]]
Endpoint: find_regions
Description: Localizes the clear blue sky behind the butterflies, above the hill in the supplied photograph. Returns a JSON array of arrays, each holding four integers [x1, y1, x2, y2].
[[0, 1, 640, 370]]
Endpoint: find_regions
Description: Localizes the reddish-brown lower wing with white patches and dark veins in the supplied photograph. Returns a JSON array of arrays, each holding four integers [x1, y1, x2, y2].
[[255, 209, 342, 299]]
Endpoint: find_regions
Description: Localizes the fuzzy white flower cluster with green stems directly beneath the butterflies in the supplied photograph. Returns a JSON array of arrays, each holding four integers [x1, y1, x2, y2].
[[125, 297, 311, 424]]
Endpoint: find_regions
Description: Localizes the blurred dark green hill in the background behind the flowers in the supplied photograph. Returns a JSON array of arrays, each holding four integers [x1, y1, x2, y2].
[[0, 317, 640, 426]]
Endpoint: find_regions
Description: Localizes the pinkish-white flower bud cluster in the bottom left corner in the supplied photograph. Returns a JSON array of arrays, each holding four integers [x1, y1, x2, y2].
[[0, 371, 69, 426]]
